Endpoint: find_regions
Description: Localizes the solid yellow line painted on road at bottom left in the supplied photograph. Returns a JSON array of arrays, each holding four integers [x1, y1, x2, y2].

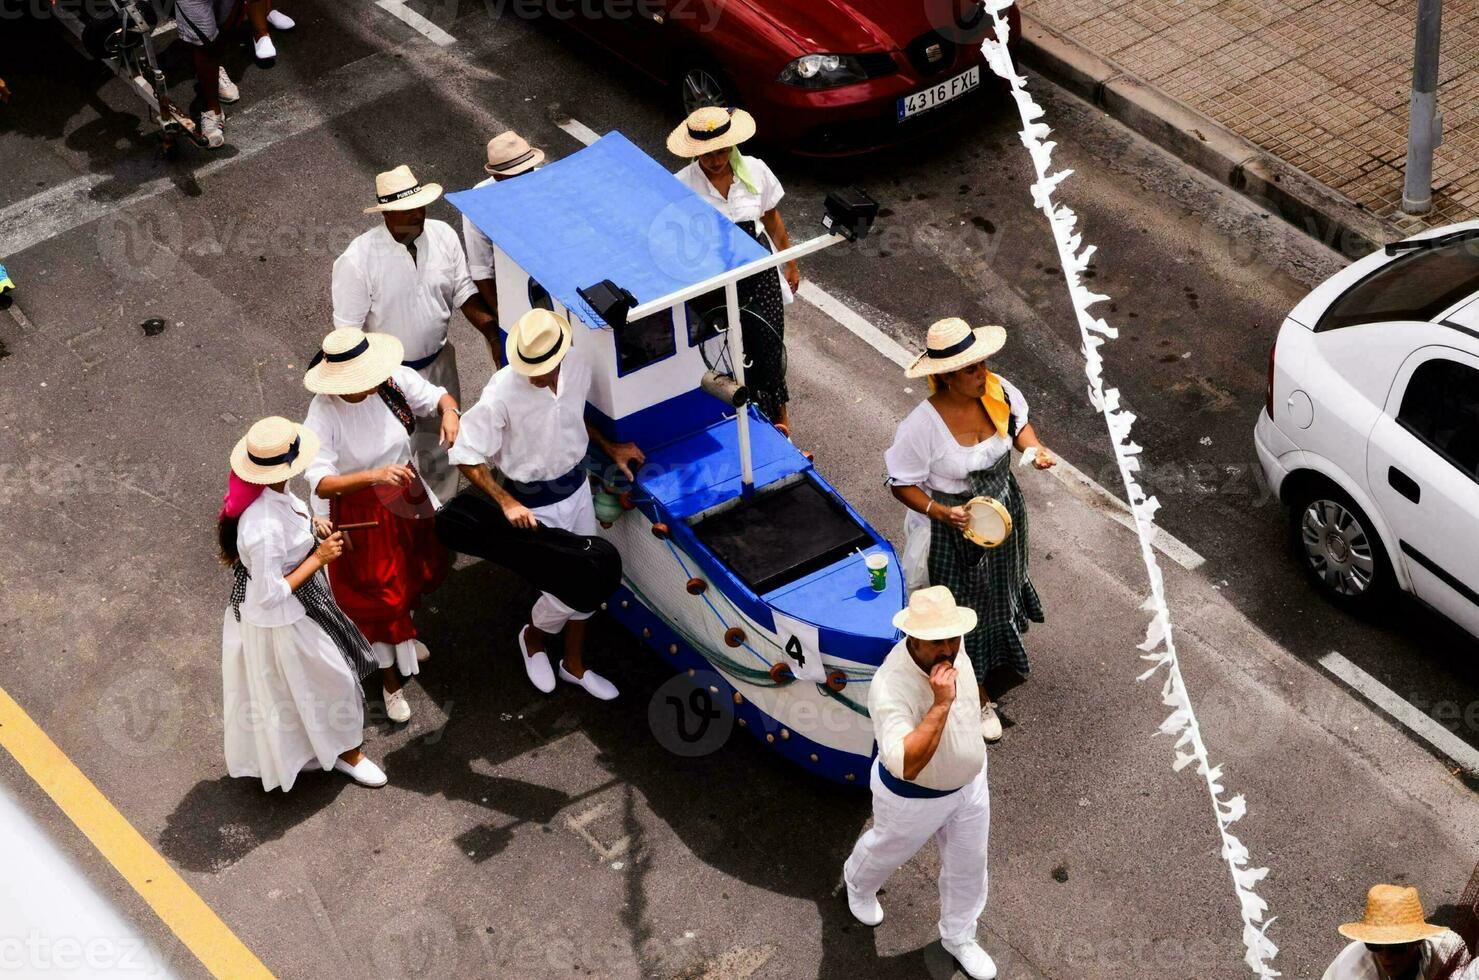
[[0, 687, 272, 980]]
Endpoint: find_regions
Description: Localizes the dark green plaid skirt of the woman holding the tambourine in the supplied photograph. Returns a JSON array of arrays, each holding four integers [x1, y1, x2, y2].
[[929, 452, 1043, 683]]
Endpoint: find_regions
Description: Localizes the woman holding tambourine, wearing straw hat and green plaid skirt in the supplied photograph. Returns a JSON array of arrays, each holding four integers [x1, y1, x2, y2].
[[884, 318, 1055, 742]]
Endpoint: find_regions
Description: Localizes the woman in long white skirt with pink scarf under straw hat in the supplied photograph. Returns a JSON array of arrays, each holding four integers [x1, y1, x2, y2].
[[217, 417, 385, 792]]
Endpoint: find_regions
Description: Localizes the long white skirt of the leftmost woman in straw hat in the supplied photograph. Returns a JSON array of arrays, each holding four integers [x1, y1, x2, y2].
[[220, 609, 365, 792]]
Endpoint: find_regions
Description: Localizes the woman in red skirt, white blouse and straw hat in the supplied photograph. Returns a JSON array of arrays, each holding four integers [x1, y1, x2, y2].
[[303, 328, 458, 721]]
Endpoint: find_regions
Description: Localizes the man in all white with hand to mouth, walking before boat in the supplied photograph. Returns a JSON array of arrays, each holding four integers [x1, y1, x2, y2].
[[842, 585, 997, 980]]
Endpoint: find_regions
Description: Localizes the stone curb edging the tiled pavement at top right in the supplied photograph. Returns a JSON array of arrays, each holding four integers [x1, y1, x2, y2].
[[1022, 13, 1412, 259]]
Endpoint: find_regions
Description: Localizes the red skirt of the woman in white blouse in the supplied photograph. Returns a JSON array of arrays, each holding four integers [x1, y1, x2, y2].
[[328, 467, 447, 643]]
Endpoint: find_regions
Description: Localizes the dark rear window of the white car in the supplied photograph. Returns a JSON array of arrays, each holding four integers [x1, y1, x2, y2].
[[1315, 239, 1479, 331]]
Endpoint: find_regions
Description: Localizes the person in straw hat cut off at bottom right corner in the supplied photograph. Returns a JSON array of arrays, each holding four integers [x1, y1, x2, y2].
[[1322, 885, 1479, 980]]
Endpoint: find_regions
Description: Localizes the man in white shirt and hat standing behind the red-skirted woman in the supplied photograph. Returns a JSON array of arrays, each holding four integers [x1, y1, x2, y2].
[[333, 166, 501, 500]]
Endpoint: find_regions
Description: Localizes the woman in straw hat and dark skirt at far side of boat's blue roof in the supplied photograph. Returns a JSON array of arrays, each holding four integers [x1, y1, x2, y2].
[[667, 106, 802, 427]]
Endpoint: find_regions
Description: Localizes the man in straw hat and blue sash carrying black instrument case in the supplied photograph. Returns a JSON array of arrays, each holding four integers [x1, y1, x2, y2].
[[450, 309, 641, 700]]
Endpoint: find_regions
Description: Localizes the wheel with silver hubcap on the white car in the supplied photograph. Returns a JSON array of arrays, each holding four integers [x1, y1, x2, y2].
[[1291, 483, 1392, 610]]
